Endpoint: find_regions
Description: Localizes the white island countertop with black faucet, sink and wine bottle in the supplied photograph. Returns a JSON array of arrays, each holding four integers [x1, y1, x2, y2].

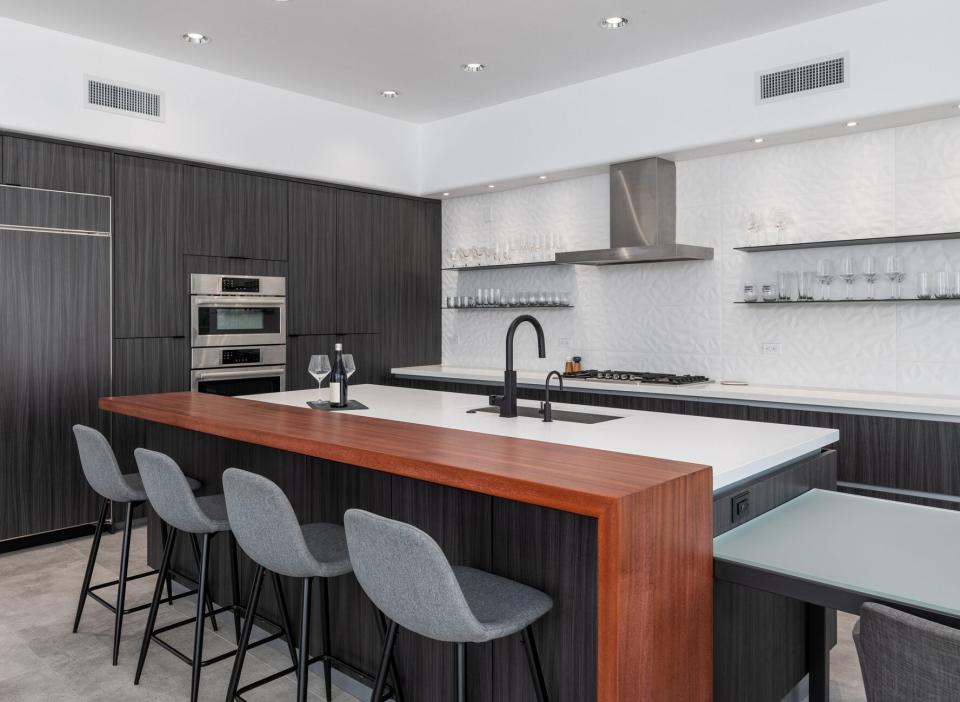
[[244, 385, 840, 491]]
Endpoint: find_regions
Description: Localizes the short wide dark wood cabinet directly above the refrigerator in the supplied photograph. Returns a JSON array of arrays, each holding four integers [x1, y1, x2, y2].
[[3, 136, 112, 195]]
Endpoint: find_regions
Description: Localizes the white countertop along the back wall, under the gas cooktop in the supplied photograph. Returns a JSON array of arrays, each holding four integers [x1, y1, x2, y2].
[[392, 365, 960, 422]]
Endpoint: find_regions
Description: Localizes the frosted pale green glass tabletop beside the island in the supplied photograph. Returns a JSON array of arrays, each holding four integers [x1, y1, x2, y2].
[[713, 490, 960, 616]]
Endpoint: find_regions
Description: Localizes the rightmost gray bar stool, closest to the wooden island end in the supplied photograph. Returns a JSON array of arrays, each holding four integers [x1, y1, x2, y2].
[[343, 509, 553, 702]]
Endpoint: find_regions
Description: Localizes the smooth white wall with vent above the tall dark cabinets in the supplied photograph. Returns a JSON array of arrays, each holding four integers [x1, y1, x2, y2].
[[0, 18, 419, 193]]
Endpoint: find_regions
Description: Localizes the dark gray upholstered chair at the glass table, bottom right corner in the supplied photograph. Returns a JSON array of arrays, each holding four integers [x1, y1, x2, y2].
[[853, 602, 960, 702]]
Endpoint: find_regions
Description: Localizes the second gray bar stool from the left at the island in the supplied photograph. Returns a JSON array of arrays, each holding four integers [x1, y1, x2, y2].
[[134, 448, 294, 702]]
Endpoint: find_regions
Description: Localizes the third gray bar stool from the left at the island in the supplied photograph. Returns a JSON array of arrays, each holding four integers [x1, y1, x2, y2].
[[223, 468, 402, 702]]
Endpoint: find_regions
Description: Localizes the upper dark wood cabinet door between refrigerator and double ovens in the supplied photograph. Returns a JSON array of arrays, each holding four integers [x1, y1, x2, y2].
[[113, 156, 186, 339]]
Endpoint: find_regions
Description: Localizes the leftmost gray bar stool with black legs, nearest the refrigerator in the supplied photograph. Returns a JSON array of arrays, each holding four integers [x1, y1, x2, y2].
[[73, 424, 208, 665]]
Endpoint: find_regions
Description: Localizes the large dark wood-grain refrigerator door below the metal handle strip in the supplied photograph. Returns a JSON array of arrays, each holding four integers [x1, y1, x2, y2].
[[0, 231, 110, 539]]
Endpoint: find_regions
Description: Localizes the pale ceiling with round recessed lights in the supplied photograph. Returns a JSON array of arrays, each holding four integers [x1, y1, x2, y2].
[[0, 0, 878, 122]]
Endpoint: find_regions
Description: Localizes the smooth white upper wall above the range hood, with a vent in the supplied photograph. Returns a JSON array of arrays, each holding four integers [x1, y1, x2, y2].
[[422, 0, 960, 193]]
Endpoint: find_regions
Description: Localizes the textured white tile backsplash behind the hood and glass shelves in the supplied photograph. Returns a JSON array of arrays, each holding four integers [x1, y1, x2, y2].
[[443, 118, 960, 395]]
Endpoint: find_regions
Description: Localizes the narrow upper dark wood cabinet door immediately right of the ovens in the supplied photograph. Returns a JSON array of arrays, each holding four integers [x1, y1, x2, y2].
[[287, 183, 339, 335]]
